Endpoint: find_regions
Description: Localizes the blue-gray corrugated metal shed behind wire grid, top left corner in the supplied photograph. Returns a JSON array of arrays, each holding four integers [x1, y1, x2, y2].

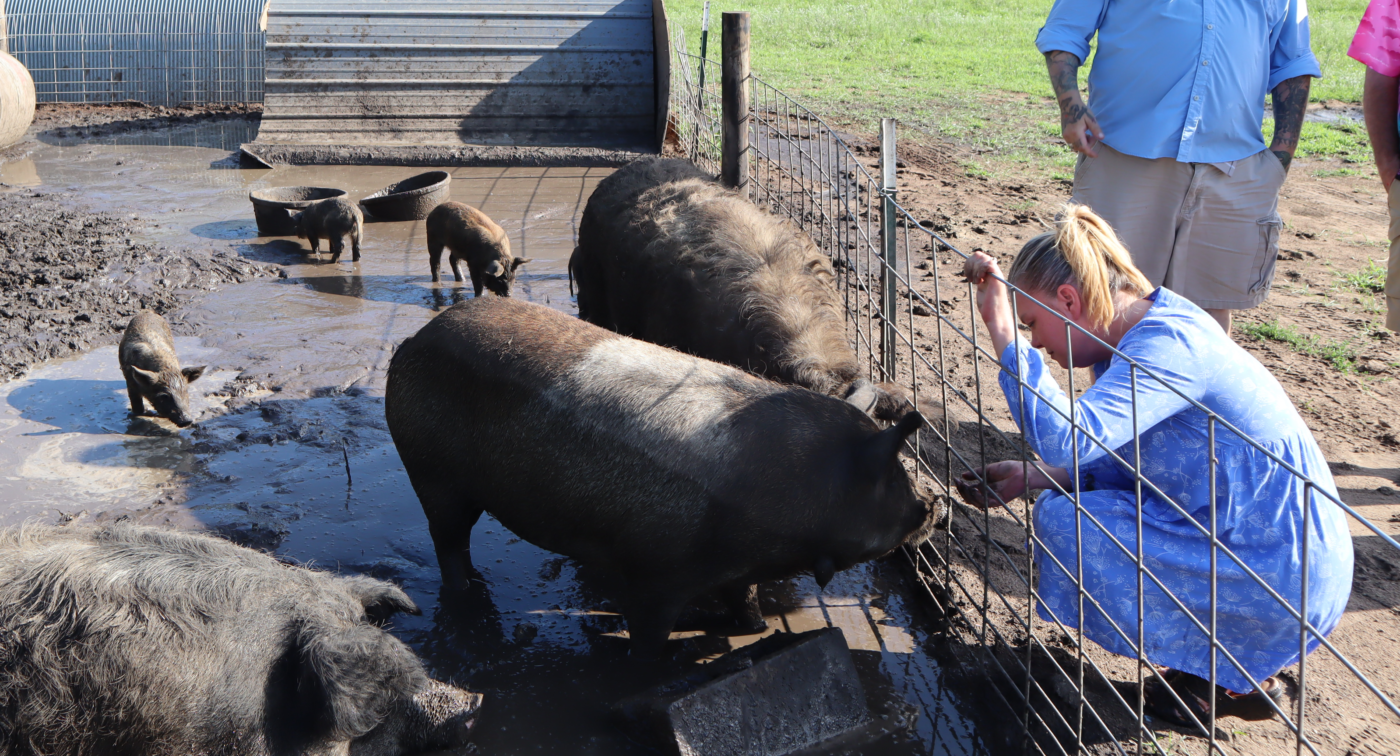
[[0, 0, 267, 106]]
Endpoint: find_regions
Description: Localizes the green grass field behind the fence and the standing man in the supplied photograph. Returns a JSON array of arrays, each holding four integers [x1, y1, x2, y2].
[[666, 0, 1369, 161]]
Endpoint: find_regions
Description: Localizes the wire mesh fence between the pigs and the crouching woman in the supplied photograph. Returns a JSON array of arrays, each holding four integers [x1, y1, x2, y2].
[[671, 35, 1400, 756]]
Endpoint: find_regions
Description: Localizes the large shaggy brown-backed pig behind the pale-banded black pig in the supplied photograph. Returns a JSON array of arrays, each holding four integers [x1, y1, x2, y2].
[[568, 160, 911, 420]]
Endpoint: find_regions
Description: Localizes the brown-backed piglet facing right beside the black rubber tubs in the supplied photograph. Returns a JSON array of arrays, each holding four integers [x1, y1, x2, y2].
[[427, 202, 529, 297]]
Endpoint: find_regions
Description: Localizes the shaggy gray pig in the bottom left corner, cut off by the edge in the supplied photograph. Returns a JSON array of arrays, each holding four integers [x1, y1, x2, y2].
[[0, 525, 480, 756]]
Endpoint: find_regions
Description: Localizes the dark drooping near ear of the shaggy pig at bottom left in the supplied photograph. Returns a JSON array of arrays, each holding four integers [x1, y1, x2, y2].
[[297, 623, 428, 741]]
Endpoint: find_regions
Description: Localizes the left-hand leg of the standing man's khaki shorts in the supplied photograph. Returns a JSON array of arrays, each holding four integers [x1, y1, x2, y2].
[[1071, 144, 1191, 286]]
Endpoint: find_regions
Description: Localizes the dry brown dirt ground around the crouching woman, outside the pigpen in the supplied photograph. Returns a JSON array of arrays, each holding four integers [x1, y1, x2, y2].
[[840, 125, 1400, 756]]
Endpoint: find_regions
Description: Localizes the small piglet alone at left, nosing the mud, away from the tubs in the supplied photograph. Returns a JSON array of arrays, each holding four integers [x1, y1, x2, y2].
[[116, 309, 204, 428]]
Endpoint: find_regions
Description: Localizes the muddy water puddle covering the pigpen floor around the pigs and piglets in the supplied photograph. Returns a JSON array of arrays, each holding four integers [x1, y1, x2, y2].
[[0, 127, 983, 755]]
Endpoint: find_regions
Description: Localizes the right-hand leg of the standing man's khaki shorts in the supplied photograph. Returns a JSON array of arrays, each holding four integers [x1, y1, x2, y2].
[[1165, 150, 1287, 333]]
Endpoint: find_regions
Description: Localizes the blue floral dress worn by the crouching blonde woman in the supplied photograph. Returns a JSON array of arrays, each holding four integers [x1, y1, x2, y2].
[[1001, 288, 1352, 693]]
